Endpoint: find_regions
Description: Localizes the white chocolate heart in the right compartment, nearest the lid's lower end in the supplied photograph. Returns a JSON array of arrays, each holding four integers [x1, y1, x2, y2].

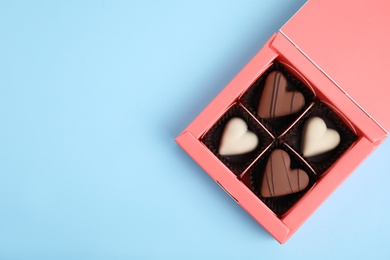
[[302, 116, 340, 157]]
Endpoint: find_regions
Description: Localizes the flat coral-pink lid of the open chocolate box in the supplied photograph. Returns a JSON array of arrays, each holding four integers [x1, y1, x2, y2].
[[280, 0, 390, 133]]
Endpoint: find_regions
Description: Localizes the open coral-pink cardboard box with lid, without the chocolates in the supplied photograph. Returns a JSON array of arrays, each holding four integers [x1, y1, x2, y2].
[[176, 0, 390, 243]]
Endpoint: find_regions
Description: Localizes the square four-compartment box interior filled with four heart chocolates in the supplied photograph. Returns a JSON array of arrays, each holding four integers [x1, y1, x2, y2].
[[202, 62, 356, 217]]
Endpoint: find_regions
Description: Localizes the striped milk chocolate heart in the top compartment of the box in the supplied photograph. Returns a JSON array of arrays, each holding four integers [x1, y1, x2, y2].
[[257, 71, 305, 118]]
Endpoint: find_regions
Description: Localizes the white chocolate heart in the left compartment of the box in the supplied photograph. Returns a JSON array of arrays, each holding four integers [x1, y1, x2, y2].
[[218, 117, 259, 156]]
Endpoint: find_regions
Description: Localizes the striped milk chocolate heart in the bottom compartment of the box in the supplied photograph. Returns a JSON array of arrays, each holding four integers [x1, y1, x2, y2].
[[261, 149, 309, 198]]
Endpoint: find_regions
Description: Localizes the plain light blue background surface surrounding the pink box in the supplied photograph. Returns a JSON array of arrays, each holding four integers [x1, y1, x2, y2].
[[0, 0, 390, 260]]
